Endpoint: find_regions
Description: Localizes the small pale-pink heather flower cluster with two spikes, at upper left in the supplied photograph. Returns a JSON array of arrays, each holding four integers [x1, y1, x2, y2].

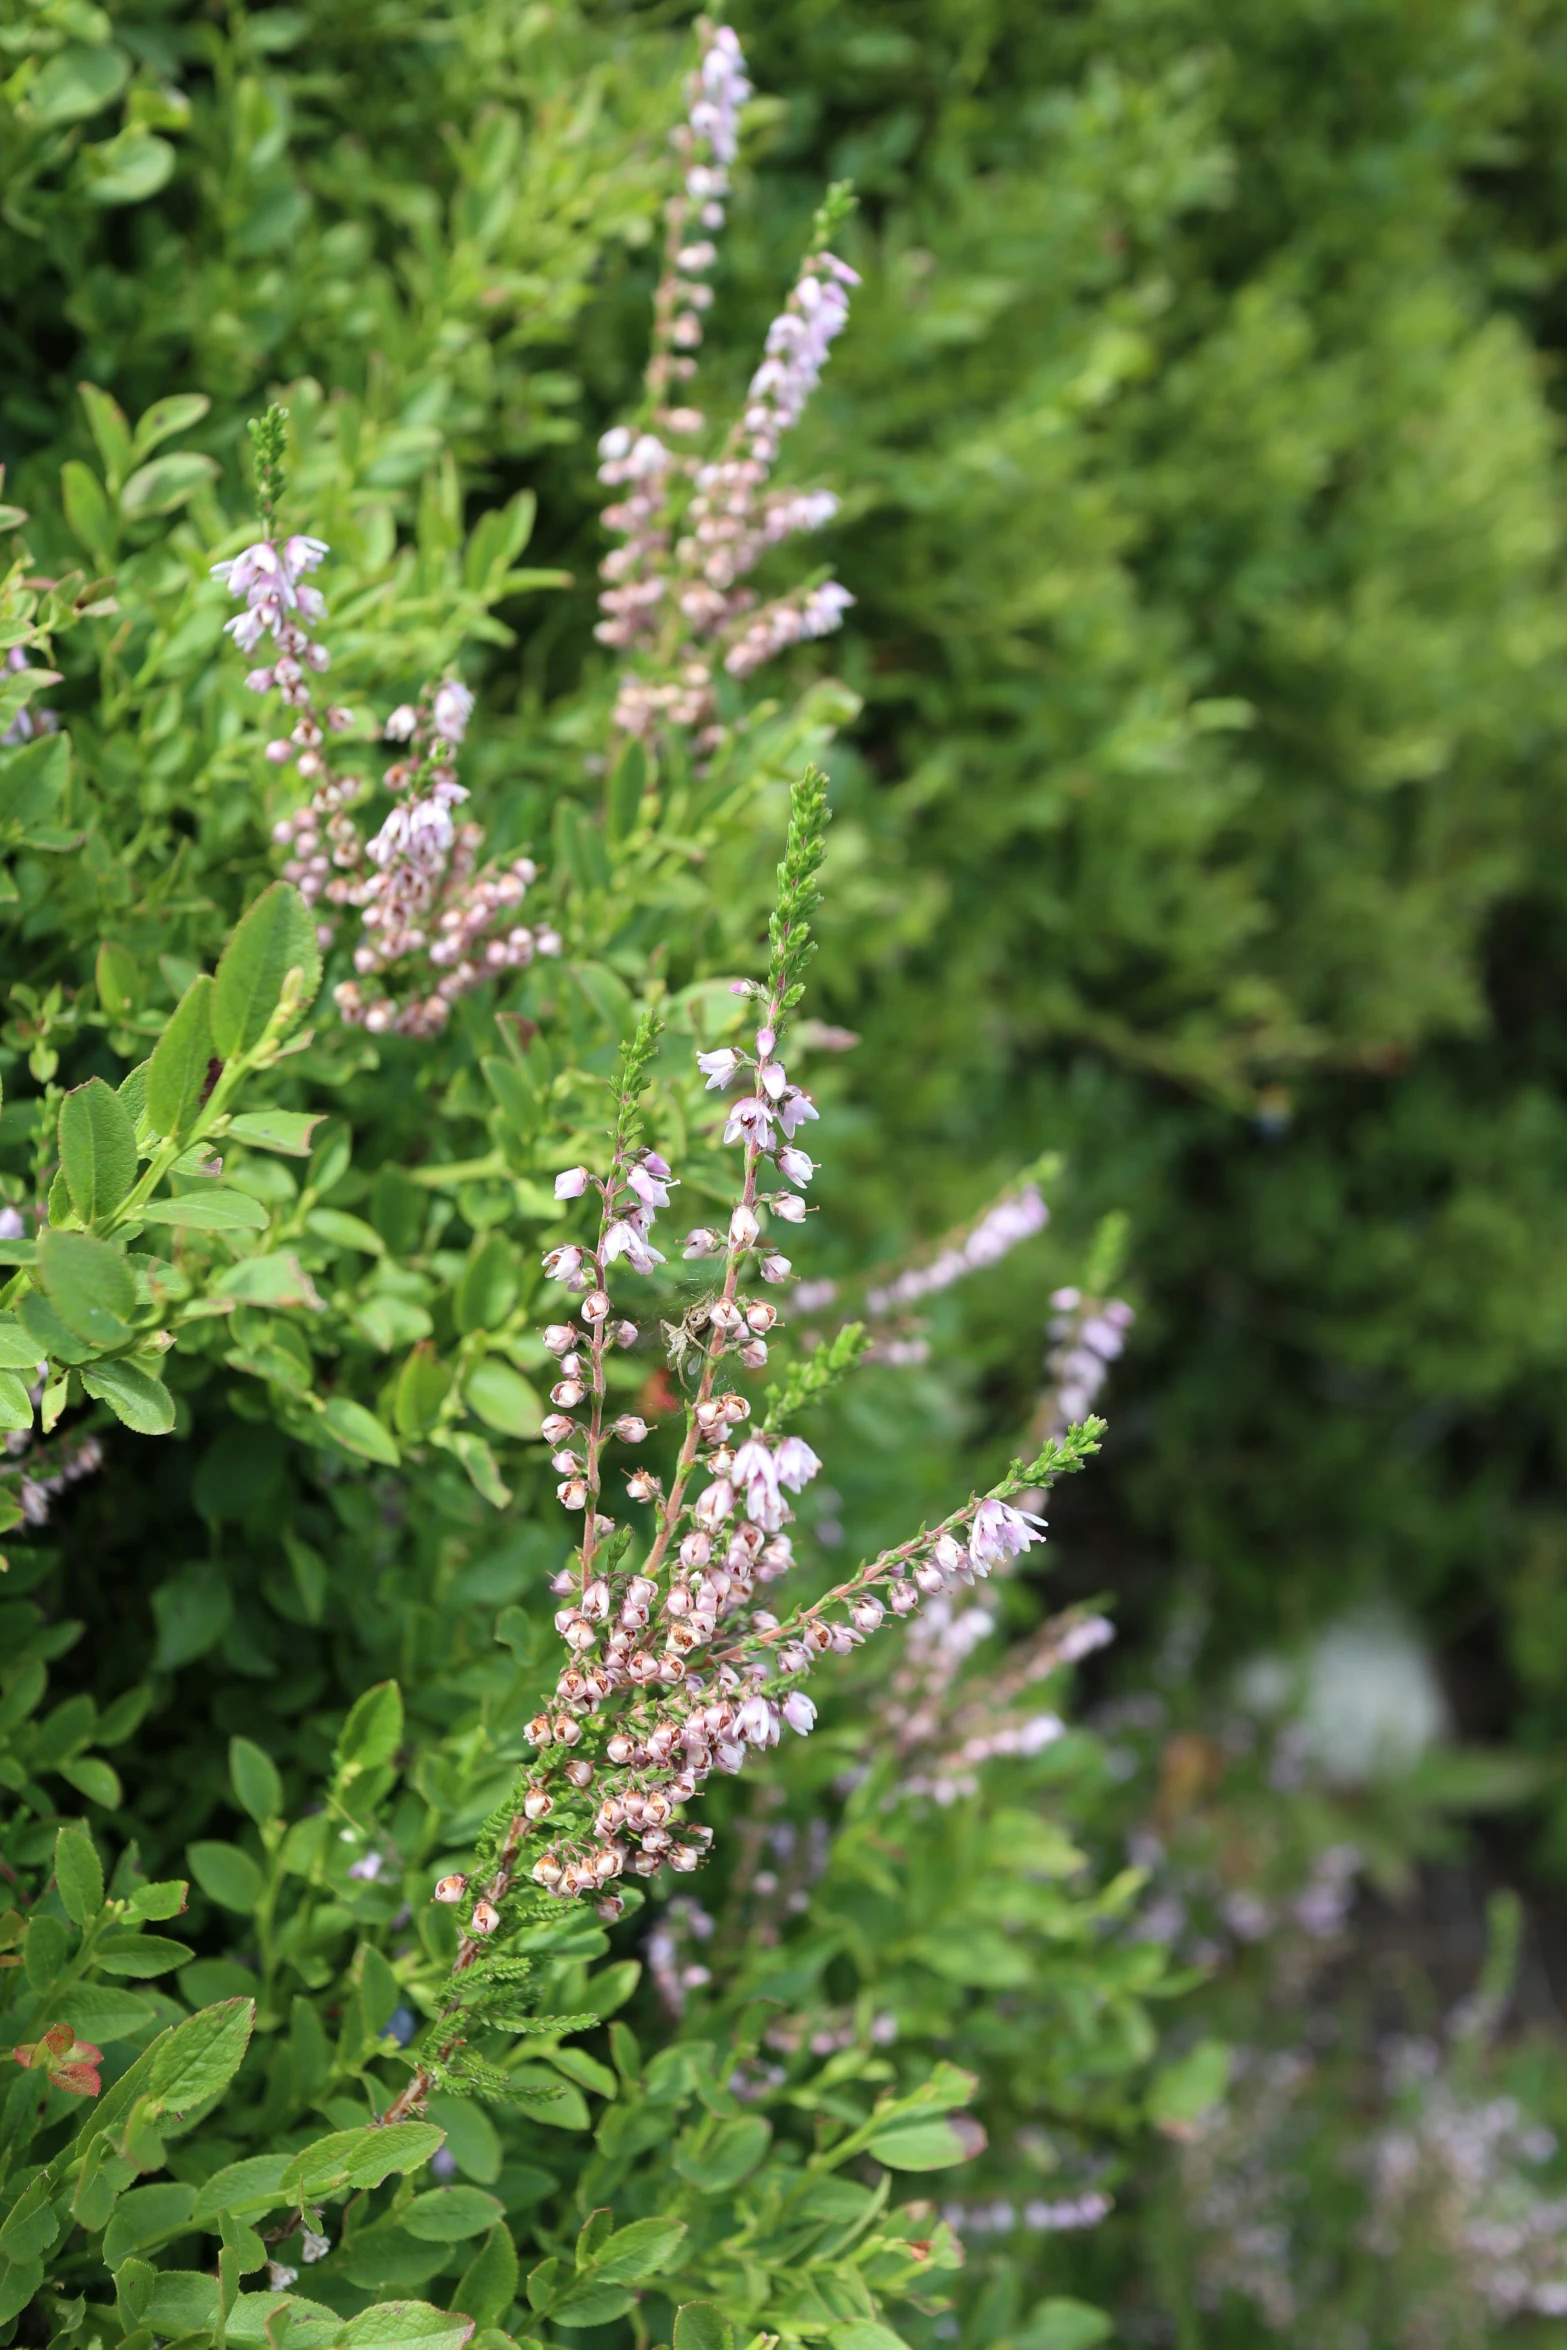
[[214, 502, 561, 1036]]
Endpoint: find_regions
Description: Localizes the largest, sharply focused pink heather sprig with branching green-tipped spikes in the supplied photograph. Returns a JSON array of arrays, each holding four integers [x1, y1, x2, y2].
[[380, 768, 1092, 2115]]
